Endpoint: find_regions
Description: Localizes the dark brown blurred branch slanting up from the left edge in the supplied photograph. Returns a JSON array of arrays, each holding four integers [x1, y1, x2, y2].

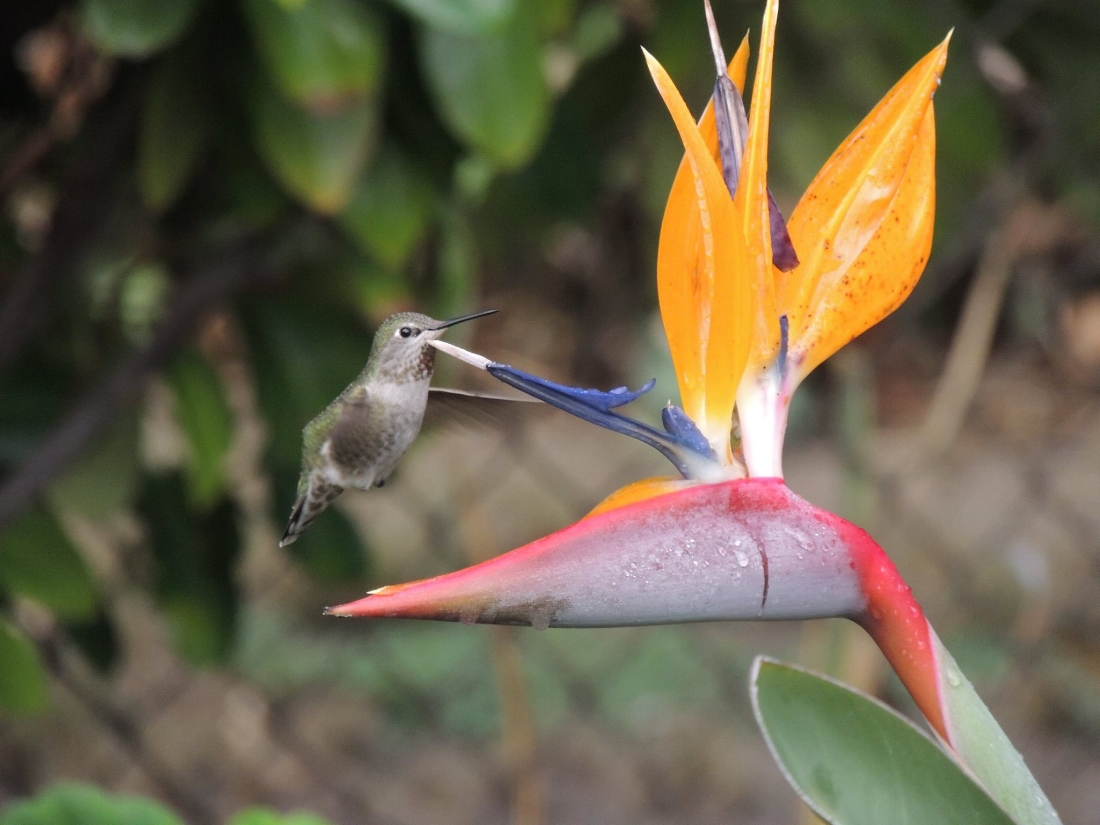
[[0, 242, 274, 529]]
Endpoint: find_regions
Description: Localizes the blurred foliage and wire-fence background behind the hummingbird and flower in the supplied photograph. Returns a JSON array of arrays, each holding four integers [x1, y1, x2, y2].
[[0, 0, 1100, 825]]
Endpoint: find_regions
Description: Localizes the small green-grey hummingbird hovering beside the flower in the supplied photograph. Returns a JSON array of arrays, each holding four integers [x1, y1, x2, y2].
[[278, 309, 512, 547]]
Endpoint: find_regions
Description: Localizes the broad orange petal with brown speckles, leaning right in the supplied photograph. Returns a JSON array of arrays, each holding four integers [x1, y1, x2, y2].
[[777, 35, 950, 380]]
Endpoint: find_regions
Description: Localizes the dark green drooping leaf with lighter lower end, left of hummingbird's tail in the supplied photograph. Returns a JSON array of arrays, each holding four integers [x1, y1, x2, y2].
[[140, 474, 240, 666]]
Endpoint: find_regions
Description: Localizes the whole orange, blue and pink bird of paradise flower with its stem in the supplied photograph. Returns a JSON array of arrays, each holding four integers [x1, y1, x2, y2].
[[328, 0, 1058, 823]]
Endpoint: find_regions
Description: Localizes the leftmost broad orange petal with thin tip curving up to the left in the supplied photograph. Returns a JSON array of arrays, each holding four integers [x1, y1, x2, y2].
[[646, 46, 751, 455]]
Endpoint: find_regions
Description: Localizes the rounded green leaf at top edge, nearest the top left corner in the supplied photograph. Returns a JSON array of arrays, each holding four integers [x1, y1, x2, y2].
[[80, 0, 199, 57]]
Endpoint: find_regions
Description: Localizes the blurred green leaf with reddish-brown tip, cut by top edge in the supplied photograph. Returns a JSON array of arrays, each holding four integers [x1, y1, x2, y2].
[[244, 0, 385, 112]]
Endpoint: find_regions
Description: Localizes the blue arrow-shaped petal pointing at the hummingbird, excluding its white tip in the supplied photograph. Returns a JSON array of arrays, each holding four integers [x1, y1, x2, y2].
[[485, 363, 717, 479]]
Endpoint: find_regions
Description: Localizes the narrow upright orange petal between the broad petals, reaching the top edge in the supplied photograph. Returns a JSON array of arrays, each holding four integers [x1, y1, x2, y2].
[[734, 0, 783, 365]]
